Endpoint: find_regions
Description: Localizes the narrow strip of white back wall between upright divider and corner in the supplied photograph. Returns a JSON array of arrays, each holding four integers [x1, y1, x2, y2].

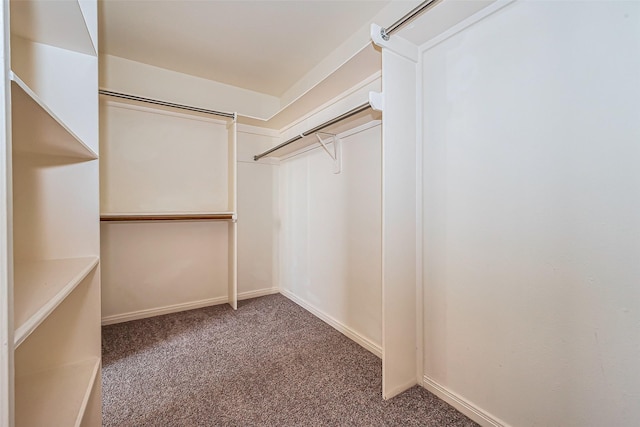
[[238, 125, 279, 298]]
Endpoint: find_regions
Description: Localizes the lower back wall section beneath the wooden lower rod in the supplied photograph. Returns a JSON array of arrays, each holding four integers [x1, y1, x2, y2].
[[100, 222, 229, 323]]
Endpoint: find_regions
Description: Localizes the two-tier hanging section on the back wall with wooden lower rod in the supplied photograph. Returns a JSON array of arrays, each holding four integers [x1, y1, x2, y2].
[[100, 94, 237, 314]]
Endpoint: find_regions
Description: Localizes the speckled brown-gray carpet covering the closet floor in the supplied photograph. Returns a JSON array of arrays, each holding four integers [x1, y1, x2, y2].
[[102, 295, 477, 426]]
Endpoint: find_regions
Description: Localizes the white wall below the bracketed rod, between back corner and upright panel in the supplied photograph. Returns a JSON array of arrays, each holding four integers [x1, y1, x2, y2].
[[279, 121, 382, 354]]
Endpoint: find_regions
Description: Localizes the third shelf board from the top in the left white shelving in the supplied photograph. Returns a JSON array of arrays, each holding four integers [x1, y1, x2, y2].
[[14, 256, 99, 347]]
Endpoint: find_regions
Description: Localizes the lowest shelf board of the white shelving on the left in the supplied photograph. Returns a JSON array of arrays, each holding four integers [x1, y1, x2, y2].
[[15, 358, 100, 426]]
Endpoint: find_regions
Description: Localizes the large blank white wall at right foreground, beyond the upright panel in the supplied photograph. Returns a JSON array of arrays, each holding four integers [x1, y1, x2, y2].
[[417, 2, 640, 427]]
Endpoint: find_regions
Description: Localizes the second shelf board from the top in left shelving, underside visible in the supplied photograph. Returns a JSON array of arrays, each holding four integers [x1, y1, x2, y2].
[[10, 72, 98, 160]]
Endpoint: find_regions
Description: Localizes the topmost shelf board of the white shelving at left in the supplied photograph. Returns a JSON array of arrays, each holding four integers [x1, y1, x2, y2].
[[11, 0, 96, 56]]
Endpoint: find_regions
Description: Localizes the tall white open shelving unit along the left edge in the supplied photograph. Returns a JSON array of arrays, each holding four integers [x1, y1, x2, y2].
[[0, 0, 101, 427]]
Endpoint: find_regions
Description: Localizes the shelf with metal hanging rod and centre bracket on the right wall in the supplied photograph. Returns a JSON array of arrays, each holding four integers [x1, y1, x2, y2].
[[253, 102, 379, 161]]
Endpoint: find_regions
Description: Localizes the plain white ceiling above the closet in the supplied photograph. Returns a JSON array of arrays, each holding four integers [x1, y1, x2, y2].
[[99, 0, 390, 96]]
